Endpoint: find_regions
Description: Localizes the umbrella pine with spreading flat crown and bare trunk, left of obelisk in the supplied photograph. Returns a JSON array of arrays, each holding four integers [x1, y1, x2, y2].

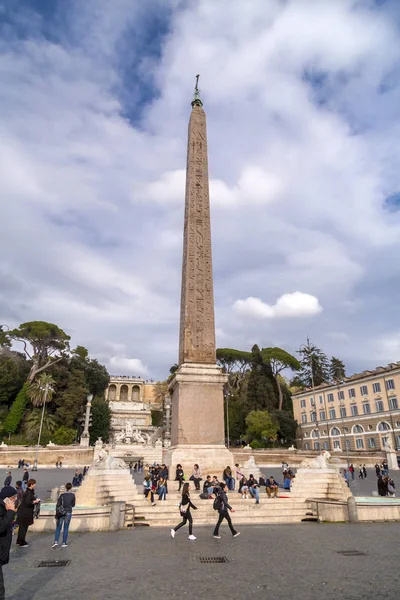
[[6, 321, 70, 383]]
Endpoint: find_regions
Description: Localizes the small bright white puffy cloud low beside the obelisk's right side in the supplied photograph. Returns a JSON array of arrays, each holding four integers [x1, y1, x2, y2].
[[233, 292, 322, 319]]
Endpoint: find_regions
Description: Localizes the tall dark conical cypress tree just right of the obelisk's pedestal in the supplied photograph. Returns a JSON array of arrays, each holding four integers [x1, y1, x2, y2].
[[246, 345, 278, 410]]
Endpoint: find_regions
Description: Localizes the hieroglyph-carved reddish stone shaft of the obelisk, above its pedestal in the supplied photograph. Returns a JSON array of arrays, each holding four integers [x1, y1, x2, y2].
[[179, 105, 216, 365]]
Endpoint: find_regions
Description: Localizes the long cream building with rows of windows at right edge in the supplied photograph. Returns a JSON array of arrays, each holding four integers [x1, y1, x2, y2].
[[292, 362, 400, 452]]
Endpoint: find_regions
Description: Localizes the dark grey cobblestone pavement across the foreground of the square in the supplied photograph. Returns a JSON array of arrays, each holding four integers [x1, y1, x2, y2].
[[4, 524, 400, 600]]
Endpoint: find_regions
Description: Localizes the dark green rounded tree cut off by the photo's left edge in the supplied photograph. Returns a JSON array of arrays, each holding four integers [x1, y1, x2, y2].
[[0, 347, 30, 405]]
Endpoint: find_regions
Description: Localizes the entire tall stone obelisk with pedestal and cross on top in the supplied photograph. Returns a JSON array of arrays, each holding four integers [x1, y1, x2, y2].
[[166, 76, 232, 476]]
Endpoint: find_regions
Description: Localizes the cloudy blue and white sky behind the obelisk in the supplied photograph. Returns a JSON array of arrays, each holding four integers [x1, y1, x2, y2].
[[0, 0, 400, 378]]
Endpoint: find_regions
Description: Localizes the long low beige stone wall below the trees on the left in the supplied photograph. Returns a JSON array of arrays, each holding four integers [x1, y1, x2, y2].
[[0, 446, 94, 468]]
